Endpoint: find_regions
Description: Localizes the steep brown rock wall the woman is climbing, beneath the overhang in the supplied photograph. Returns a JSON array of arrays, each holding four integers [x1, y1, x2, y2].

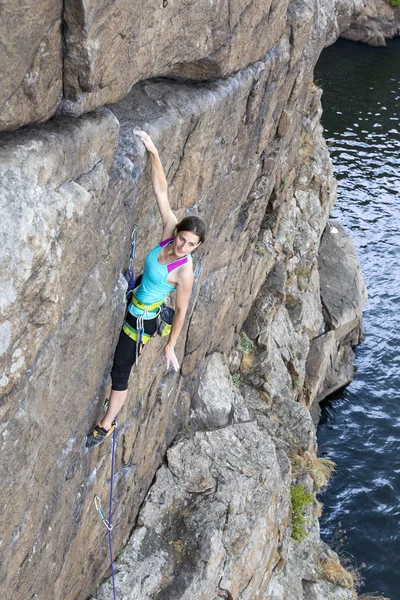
[[0, 40, 318, 600]]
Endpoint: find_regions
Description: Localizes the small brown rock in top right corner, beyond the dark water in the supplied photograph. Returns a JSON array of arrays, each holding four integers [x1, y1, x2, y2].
[[342, 0, 400, 46]]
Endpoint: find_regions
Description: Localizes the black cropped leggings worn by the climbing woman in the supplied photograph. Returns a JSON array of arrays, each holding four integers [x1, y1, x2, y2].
[[111, 313, 157, 392]]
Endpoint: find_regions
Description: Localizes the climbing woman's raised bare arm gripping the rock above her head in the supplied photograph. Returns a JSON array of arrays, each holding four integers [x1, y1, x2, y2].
[[133, 129, 178, 239]]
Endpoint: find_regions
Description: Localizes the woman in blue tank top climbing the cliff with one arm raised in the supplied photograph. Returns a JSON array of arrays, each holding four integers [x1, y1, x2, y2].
[[86, 129, 205, 448]]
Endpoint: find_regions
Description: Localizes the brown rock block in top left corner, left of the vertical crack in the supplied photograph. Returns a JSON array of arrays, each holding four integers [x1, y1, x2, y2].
[[0, 0, 62, 131]]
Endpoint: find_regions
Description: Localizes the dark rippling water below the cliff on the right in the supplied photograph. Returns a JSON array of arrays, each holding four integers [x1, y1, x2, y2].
[[315, 39, 400, 600]]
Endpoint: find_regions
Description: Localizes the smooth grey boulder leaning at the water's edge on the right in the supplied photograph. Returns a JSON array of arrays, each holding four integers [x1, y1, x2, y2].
[[300, 221, 367, 422]]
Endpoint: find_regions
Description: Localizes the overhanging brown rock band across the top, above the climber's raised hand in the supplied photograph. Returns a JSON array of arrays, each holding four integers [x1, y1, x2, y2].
[[0, 0, 366, 131]]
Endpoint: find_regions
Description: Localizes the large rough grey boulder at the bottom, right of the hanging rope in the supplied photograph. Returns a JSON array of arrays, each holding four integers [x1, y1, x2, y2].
[[92, 423, 289, 600]]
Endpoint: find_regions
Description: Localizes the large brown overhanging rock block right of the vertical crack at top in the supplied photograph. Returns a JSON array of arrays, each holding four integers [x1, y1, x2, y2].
[[64, 0, 288, 114]]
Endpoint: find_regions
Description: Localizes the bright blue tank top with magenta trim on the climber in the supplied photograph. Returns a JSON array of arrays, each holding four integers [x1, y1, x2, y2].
[[128, 238, 192, 319]]
